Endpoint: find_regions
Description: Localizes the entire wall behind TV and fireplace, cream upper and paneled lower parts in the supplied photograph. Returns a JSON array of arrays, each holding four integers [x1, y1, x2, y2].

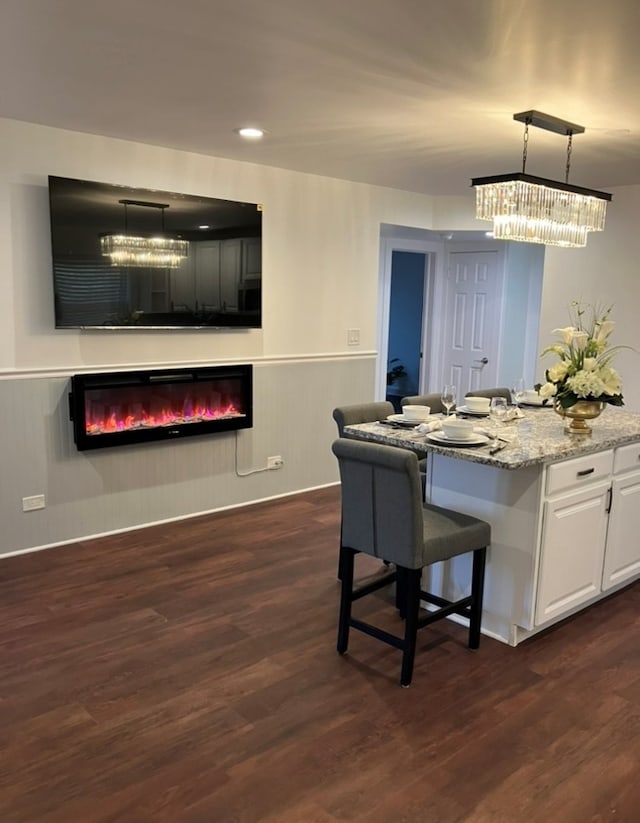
[[0, 120, 456, 554]]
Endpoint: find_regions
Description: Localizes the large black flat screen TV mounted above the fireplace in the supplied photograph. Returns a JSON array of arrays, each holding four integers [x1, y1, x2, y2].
[[49, 176, 262, 329]]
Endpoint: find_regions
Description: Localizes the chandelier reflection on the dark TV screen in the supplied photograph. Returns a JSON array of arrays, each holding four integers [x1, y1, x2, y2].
[[100, 200, 189, 269]]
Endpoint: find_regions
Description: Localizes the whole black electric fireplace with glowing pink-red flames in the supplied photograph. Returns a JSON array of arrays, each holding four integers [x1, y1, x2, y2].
[[69, 365, 253, 451]]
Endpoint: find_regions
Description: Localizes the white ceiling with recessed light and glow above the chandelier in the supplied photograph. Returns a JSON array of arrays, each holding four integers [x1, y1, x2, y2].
[[0, 0, 640, 194]]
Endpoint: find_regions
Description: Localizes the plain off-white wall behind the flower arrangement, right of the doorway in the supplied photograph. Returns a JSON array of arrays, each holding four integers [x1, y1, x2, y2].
[[538, 186, 640, 411]]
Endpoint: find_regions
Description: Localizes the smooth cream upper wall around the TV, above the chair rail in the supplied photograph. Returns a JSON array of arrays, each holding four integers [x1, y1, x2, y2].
[[0, 120, 410, 369]]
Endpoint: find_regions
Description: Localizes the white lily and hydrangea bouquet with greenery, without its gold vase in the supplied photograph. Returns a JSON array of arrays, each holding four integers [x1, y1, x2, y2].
[[536, 301, 625, 409]]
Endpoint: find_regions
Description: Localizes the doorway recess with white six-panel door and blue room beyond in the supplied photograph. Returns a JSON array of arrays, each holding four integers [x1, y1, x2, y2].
[[376, 224, 544, 408]]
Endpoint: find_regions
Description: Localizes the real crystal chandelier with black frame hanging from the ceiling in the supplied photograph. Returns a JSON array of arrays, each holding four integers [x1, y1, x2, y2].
[[471, 111, 611, 248]]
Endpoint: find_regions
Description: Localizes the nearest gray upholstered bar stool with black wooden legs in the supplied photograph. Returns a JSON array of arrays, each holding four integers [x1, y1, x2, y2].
[[332, 439, 491, 686]]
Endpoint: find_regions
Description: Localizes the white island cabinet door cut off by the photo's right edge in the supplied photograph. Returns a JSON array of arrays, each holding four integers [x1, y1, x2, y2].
[[602, 472, 640, 591]]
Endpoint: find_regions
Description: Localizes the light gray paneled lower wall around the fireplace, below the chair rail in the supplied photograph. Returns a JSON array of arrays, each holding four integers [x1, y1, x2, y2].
[[0, 355, 375, 555]]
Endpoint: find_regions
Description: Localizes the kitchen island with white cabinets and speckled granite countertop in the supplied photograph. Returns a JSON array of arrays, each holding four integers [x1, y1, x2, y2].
[[345, 407, 640, 646]]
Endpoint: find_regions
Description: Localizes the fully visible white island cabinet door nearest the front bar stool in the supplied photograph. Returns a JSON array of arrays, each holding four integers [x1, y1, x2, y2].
[[536, 482, 610, 626]]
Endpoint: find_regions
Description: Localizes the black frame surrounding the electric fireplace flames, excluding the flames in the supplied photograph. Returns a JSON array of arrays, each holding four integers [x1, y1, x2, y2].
[[69, 364, 253, 451]]
